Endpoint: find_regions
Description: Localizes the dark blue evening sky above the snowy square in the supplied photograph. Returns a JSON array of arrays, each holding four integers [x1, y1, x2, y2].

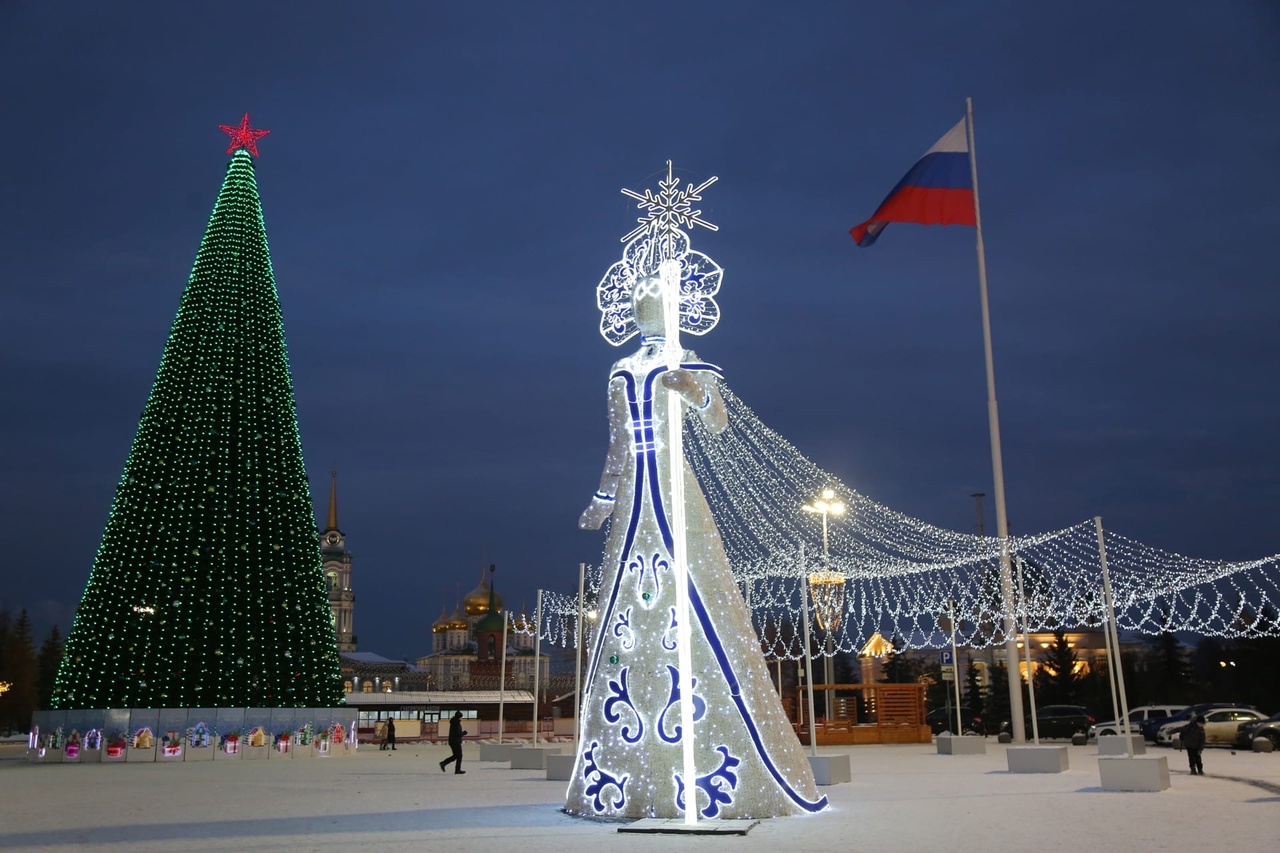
[[0, 0, 1280, 657]]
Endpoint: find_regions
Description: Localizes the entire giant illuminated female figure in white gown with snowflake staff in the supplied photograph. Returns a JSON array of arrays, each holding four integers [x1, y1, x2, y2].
[[564, 161, 827, 824]]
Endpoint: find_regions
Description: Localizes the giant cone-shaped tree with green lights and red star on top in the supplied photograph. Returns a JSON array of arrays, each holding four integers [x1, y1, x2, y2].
[[51, 115, 342, 708]]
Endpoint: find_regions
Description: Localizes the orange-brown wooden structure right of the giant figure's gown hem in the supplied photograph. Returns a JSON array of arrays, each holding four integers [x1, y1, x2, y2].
[[783, 683, 933, 747]]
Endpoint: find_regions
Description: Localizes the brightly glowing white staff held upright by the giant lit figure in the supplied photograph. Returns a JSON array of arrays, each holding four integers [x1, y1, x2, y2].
[[658, 257, 698, 825]]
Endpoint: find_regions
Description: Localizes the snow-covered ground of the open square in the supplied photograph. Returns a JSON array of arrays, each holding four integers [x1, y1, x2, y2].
[[0, 740, 1280, 853]]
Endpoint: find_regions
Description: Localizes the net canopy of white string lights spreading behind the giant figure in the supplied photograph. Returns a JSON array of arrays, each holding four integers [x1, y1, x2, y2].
[[524, 384, 1280, 660]]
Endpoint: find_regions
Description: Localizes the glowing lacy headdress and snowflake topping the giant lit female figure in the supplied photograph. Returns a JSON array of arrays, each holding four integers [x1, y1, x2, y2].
[[595, 160, 724, 347]]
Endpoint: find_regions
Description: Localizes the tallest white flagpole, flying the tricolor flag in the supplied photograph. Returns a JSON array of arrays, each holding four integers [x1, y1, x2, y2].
[[964, 97, 1029, 743]]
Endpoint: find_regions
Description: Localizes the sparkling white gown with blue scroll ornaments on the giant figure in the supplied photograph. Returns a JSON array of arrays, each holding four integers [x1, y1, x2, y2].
[[564, 330, 827, 820]]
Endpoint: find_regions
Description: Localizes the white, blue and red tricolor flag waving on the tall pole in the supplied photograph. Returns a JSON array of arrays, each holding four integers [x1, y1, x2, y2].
[[849, 119, 977, 246]]
